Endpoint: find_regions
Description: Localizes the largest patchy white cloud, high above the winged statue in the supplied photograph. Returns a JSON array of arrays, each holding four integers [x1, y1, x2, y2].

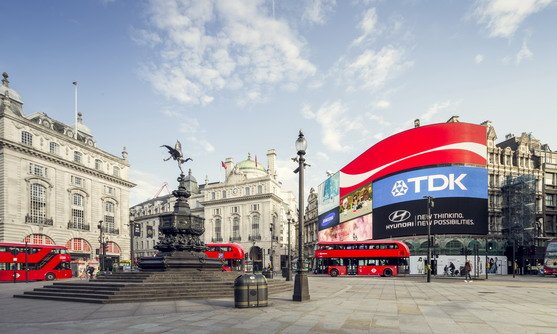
[[134, 0, 316, 105]]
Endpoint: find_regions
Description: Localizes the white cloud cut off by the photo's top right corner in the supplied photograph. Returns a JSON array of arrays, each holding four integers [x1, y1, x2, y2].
[[473, 0, 554, 38]]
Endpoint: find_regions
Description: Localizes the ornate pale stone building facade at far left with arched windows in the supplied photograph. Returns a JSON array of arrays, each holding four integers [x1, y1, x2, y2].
[[0, 73, 135, 261]]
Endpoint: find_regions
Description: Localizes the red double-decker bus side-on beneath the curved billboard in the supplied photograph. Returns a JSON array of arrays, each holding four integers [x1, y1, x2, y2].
[[315, 240, 410, 277]]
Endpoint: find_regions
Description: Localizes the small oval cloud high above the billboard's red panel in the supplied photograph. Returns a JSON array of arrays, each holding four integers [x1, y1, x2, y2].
[[343, 46, 412, 90]]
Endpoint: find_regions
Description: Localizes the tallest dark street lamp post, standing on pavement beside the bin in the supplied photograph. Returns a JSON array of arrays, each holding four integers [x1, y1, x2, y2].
[[292, 130, 309, 302]]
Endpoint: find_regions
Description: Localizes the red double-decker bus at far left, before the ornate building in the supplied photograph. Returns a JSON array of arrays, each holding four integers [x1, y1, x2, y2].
[[0, 243, 72, 281]]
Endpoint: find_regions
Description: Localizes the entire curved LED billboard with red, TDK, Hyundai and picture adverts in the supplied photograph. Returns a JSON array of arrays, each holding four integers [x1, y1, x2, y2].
[[318, 122, 487, 241]]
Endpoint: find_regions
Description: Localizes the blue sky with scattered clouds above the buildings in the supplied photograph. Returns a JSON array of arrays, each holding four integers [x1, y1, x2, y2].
[[0, 0, 557, 205]]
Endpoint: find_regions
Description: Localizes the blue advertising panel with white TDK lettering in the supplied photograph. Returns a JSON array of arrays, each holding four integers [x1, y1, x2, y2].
[[373, 166, 487, 209]]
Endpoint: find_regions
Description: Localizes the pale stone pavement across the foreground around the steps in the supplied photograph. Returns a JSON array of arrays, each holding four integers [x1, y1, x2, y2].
[[0, 276, 557, 334]]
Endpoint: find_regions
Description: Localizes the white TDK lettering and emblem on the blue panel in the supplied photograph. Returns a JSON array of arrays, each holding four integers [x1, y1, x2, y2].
[[391, 174, 468, 197]]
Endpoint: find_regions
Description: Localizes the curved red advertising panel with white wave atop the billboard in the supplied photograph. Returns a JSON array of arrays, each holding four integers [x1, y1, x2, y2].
[[340, 122, 487, 198]]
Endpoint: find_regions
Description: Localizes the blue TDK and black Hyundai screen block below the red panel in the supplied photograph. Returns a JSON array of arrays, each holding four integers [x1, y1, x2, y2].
[[373, 166, 488, 239]]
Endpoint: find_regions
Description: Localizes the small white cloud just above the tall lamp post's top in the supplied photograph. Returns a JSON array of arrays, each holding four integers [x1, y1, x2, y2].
[[302, 101, 364, 151]]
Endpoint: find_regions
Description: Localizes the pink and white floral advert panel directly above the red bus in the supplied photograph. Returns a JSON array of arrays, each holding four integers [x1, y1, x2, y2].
[[317, 214, 373, 241]]
